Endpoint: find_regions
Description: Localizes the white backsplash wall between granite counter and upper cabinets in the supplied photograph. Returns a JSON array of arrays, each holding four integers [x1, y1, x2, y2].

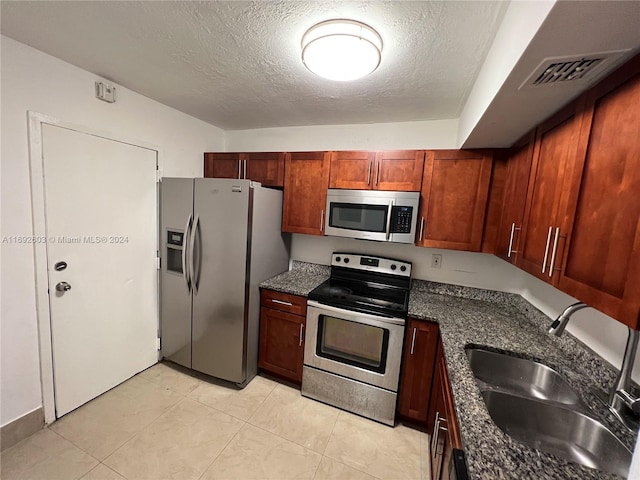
[[291, 235, 640, 382]]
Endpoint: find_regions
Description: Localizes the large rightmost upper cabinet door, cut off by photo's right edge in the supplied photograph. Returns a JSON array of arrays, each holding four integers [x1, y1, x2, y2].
[[558, 65, 640, 329]]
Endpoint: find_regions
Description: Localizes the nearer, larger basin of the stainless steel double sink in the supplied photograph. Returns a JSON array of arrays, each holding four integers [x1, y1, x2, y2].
[[482, 390, 631, 477]]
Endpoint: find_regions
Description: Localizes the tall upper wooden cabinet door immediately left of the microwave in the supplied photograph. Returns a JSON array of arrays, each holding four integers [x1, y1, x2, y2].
[[282, 152, 331, 235]]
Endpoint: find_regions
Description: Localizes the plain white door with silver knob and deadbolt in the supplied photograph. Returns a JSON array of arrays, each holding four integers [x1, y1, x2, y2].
[[42, 124, 158, 417]]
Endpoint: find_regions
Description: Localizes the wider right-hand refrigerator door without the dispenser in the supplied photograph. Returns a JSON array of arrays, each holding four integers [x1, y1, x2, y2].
[[192, 178, 252, 384]]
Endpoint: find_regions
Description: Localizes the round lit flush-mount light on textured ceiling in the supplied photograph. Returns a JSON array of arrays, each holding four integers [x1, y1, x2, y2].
[[302, 20, 382, 82]]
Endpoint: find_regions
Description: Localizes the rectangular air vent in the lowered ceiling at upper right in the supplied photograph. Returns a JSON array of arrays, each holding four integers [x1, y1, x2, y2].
[[520, 50, 628, 88]]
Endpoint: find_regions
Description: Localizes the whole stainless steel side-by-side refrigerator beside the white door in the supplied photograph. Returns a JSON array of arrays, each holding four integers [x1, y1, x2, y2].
[[160, 178, 289, 386]]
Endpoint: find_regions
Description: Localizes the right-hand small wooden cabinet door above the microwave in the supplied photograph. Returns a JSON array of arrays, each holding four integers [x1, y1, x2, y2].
[[372, 150, 424, 192]]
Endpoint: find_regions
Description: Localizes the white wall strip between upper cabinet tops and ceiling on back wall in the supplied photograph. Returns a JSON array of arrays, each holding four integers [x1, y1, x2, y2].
[[226, 119, 458, 152]]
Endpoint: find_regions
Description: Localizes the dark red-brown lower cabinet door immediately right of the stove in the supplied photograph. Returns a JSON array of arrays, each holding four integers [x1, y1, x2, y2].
[[398, 319, 438, 424]]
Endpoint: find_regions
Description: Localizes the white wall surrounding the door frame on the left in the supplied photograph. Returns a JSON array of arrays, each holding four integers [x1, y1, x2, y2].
[[0, 36, 224, 425]]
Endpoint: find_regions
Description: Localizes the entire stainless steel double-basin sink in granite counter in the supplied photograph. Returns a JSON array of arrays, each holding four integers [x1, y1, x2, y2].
[[466, 348, 632, 477]]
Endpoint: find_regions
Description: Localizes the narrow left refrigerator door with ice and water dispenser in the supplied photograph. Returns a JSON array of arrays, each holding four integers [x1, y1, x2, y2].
[[160, 178, 193, 368]]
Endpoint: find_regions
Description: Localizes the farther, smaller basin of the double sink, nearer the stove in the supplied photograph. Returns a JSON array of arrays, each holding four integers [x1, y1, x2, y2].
[[467, 348, 580, 406]]
